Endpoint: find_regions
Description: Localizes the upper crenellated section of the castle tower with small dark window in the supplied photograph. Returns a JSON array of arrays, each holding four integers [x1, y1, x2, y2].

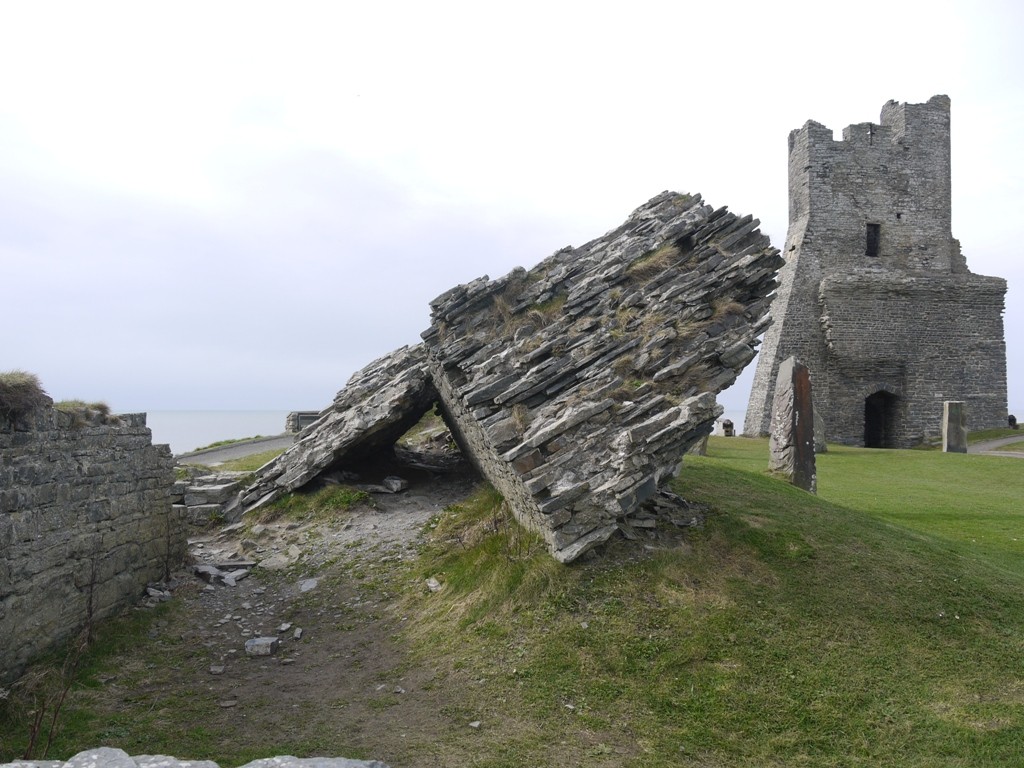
[[790, 96, 967, 273]]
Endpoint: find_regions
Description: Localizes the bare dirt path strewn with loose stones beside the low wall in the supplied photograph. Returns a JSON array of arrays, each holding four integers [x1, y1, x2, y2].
[[100, 460, 487, 766]]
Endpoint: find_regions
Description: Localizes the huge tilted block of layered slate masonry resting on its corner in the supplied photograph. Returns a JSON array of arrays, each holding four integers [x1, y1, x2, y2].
[[423, 193, 781, 562]]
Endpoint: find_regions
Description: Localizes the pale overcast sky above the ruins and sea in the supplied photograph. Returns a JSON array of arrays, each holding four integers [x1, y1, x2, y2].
[[0, 0, 1024, 416]]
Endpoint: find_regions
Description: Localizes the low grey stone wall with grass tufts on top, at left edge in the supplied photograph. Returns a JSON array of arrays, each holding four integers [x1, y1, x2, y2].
[[0, 404, 185, 682]]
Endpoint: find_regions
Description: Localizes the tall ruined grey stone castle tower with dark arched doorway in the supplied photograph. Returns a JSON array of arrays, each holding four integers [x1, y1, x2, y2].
[[743, 96, 1007, 447]]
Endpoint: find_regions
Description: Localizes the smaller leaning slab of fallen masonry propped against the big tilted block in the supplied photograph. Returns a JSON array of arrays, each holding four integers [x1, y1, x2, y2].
[[232, 344, 437, 515]]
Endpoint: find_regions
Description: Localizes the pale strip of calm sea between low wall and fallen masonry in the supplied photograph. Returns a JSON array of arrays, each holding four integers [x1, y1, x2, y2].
[[145, 411, 289, 456]]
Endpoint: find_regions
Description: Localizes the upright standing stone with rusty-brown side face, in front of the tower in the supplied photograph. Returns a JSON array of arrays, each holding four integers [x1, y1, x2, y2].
[[768, 357, 817, 494]]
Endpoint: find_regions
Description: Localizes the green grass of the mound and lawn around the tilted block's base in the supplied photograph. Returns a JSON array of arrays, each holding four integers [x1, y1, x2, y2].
[[401, 439, 1024, 766]]
